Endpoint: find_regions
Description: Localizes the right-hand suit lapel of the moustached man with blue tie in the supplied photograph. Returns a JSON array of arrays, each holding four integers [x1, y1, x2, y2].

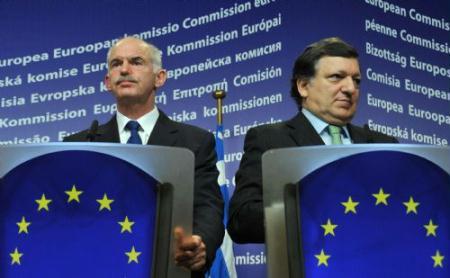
[[147, 110, 178, 146]]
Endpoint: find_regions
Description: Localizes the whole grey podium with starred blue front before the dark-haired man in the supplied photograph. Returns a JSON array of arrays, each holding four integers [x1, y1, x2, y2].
[[262, 144, 450, 278]]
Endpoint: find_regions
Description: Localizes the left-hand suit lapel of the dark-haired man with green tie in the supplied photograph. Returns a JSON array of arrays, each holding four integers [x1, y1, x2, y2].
[[286, 112, 325, 146]]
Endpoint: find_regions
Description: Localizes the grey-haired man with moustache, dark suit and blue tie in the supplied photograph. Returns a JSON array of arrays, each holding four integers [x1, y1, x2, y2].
[[64, 37, 224, 277]]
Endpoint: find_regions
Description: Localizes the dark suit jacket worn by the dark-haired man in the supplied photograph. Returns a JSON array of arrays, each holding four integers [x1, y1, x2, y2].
[[227, 112, 397, 243]]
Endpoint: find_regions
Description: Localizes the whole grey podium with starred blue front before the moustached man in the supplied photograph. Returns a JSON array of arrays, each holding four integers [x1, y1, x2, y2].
[[0, 143, 194, 277]]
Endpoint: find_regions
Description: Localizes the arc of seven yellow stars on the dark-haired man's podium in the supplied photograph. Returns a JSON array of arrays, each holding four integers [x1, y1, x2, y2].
[[314, 188, 445, 268]]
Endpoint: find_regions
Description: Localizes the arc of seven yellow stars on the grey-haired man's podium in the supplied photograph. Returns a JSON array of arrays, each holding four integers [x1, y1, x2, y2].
[[9, 185, 142, 265]]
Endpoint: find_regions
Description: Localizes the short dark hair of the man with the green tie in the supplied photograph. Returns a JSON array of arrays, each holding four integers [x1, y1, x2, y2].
[[291, 37, 359, 109]]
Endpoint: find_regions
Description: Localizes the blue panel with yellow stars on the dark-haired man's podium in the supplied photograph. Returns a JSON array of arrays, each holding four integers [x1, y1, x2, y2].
[[299, 151, 450, 277]]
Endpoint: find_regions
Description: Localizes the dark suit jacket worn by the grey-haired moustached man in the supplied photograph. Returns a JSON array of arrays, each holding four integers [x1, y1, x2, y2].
[[64, 111, 224, 274]]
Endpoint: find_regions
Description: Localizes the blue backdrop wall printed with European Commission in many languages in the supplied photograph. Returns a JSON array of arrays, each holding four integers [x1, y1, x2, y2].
[[0, 0, 450, 276]]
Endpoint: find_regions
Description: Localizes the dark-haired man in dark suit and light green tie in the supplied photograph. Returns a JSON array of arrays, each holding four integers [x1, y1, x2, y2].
[[227, 38, 397, 243]]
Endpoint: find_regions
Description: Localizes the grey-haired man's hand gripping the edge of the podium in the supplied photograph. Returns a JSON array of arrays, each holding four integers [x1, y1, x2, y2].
[[174, 227, 206, 271]]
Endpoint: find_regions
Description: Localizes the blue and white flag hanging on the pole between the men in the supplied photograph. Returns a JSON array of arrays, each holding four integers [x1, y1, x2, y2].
[[206, 125, 237, 278]]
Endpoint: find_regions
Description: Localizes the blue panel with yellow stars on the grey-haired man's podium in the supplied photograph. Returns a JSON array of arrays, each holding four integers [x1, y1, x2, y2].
[[0, 151, 157, 278]]
